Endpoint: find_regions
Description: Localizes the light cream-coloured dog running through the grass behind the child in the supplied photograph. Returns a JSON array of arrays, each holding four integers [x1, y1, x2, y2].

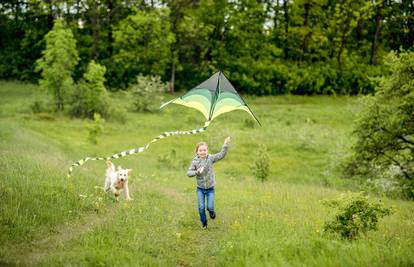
[[104, 160, 132, 201]]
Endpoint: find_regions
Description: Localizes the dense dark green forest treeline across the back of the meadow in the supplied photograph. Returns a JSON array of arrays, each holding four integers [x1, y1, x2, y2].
[[0, 0, 414, 95]]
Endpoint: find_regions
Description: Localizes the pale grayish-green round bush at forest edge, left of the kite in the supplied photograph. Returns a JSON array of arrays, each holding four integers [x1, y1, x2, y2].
[[129, 74, 168, 112]]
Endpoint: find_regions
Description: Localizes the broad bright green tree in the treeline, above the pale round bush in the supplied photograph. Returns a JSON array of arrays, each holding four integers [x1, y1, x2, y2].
[[113, 8, 174, 87]]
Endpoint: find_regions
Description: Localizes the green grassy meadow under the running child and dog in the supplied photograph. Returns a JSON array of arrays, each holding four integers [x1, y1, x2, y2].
[[0, 82, 414, 266]]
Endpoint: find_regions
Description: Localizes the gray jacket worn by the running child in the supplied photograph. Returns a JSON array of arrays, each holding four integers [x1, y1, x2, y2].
[[187, 145, 228, 189]]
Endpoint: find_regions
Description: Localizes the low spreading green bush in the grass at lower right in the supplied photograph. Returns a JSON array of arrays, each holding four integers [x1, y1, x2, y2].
[[324, 193, 393, 240]]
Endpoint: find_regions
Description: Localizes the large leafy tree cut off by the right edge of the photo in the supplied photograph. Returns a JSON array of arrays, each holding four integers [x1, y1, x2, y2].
[[346, 52, 414, 198]]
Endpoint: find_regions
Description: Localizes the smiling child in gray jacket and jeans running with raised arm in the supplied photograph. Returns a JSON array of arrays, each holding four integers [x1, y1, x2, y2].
[[187, 137, 230, 229]]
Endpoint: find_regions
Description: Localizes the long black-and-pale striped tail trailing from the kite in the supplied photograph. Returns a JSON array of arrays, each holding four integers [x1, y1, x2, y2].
[[68, 121, 211, 178]]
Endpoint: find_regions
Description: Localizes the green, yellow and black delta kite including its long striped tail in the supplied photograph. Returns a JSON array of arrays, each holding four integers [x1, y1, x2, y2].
[[68, 71, 261, 177]]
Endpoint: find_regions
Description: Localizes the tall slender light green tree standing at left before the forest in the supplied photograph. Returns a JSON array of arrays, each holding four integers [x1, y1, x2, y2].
[[36, 20, 79, 111]]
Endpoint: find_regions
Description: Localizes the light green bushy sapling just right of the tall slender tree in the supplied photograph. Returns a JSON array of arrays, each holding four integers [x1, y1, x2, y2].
[[71, 60, 109, 118]]
